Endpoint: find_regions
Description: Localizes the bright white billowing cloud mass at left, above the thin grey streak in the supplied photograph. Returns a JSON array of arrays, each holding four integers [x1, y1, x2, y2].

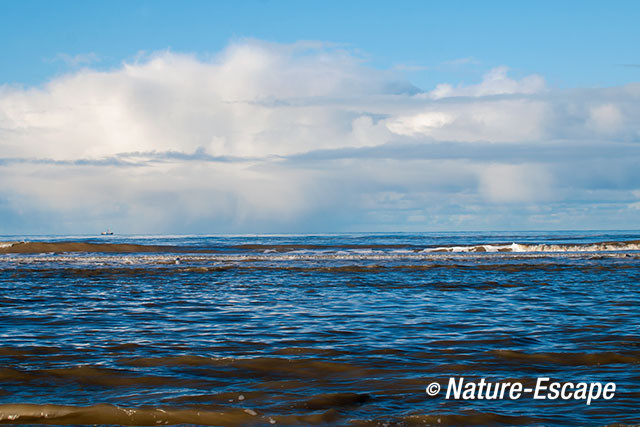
[[0, 42, 416, 159]]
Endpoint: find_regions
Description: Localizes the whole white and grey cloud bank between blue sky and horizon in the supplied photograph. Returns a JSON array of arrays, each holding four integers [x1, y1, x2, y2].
[[0, 41, 640, 233]]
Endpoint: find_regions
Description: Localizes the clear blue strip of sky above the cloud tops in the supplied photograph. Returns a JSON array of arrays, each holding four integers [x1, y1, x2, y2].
[[0, 0, 640, 89]]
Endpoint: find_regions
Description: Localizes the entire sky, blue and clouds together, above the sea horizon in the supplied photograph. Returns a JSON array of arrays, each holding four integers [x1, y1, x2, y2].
[[0, 0, 640, 234]]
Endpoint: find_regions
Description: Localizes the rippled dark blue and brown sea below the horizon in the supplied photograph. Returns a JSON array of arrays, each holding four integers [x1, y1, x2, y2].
[[0, 231, 640, 426]]
